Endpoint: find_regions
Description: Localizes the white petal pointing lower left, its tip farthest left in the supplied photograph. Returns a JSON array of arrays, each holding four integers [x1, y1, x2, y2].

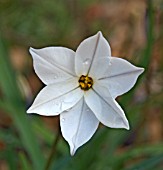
[[27, 78, 83, 116]]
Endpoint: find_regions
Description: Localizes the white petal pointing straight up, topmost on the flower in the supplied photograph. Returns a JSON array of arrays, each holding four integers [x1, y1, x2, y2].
[[75, 32, 111, 76]]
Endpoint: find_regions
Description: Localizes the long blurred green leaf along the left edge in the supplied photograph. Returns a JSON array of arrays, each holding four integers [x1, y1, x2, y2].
[[0, 37, 44, 170]]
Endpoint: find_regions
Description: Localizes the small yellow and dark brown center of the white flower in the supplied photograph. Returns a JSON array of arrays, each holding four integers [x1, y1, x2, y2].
[[78, 75, 93, 91]]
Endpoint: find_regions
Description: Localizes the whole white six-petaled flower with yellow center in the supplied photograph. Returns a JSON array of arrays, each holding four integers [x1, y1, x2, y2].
[[27, 32, 144, 155]]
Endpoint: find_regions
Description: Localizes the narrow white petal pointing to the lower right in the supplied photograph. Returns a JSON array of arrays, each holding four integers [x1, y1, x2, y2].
[[84, 85, 129, 129]]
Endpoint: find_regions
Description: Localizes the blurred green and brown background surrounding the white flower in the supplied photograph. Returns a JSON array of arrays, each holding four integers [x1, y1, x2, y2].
[[0, 0, 163, 170]]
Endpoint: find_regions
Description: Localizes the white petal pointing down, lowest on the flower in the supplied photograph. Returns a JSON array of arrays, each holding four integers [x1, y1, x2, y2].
[[60, 98, 99, 155]]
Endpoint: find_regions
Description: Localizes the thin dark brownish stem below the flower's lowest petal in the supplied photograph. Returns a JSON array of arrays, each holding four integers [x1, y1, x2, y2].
[[45, 130, 60, 170]]
